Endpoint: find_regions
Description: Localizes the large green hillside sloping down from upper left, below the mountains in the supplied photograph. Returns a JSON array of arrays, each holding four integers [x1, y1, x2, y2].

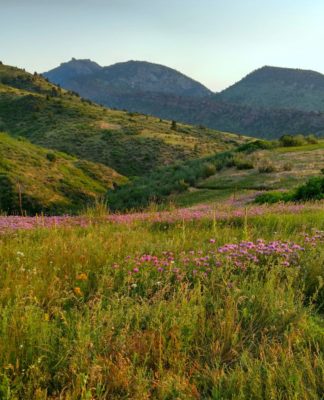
[[0, 61, 246, 176]]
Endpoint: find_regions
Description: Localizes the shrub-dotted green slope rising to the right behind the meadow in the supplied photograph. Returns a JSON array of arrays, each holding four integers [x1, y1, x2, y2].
[[108, 140, 324, 210]]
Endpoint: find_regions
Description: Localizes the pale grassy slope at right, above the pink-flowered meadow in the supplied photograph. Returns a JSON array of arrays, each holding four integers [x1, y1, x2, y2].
[[173, 141, 324, 205]]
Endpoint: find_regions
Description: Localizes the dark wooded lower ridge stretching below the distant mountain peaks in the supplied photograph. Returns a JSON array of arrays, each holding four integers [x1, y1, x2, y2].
[[114, 94, 324, 139]]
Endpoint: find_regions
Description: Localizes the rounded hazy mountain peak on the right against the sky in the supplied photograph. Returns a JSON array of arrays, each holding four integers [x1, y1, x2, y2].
[[216, 66, 324, 112]]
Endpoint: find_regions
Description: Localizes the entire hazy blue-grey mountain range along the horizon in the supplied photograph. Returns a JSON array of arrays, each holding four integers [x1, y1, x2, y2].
[[43, 59, 324, 138]]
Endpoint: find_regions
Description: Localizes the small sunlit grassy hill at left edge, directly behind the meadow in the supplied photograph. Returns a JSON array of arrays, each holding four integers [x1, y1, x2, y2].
[[0, 133, 127, 213]]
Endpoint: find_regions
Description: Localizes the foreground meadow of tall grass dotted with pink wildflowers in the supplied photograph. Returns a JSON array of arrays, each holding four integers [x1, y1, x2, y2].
[[0, 202, 324, 400]]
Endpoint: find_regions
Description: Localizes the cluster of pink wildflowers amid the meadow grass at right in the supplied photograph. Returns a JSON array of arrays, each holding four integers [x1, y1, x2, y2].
[[122, 239, 314, 279]]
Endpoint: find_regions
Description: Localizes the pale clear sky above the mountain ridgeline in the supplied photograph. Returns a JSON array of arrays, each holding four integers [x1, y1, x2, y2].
[[0, 0, 324, 91]]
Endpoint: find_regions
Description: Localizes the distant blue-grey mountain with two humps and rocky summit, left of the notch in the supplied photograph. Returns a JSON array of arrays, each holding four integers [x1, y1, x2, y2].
[[43, 59, 212, 108]]
